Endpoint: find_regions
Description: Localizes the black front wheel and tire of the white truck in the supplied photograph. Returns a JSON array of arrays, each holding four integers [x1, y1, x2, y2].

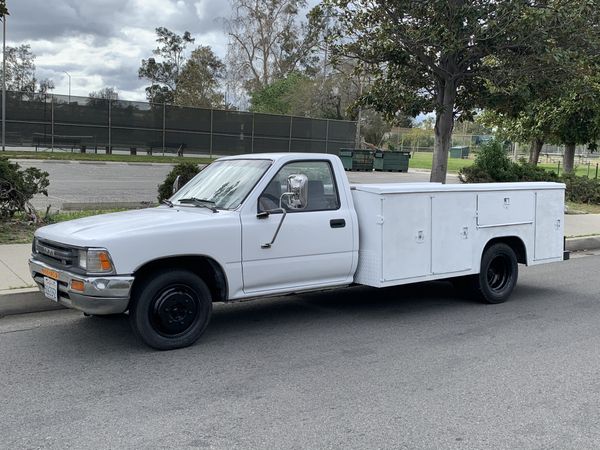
[[129, 269, 212, 350]]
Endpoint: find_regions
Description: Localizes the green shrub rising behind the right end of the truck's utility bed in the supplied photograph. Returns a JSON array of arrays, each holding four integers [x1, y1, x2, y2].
[[458, 140, 558, 183]]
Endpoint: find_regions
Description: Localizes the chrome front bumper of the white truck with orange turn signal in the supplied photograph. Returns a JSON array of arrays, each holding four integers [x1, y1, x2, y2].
[[29, 259, 133, 315]]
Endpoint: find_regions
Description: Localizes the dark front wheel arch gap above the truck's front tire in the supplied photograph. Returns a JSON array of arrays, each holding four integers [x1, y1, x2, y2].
[[132, 255, 229, 302]]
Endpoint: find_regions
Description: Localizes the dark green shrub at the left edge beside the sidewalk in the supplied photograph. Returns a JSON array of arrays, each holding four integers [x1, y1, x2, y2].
[[0, 156, 50, 219]]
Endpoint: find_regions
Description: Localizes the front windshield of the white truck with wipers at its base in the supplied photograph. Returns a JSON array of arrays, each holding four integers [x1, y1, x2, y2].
[[171, 159, 271, 209]]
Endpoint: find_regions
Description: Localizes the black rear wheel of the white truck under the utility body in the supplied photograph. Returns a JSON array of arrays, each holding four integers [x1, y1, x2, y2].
[[451, 243, 519, 304]]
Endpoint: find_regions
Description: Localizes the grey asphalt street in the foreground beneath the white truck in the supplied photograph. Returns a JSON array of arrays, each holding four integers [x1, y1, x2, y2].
[[0, 256, 600, 449]]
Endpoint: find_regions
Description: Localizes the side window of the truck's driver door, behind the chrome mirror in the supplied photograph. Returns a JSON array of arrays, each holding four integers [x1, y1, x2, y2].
[[258, 161, 340, 212]]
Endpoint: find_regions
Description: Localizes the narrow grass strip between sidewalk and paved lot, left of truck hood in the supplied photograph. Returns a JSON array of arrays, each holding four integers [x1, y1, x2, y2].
[[0, 209, 132, 244]]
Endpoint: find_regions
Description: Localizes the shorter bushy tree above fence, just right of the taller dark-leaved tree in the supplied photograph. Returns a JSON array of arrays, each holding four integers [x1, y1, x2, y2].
[[174, 45, 225, 108]]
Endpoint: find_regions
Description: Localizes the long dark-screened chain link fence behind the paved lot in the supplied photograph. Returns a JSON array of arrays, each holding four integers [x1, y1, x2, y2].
[[0, 92, 356, 157]]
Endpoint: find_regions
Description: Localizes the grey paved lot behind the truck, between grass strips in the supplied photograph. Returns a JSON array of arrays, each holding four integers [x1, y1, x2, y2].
[[19, 160, 457, 209]]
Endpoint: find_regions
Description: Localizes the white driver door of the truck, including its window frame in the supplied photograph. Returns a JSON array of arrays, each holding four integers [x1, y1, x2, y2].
[[242, 161, 353, 293]]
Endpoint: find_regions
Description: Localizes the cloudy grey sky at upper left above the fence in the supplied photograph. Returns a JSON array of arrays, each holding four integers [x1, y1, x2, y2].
[[7, 0, 255, 100]]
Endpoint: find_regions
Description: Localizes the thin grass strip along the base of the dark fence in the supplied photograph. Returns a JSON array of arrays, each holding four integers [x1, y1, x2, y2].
[[0, 150, 212, 164]]
